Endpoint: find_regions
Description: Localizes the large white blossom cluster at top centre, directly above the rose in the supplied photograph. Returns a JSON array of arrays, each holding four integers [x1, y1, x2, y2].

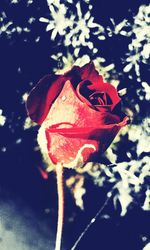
[[40, 0, 105, 58]]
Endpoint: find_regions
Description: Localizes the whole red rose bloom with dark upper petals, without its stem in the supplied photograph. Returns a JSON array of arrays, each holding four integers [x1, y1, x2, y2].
[[27, 63, 128, 167]]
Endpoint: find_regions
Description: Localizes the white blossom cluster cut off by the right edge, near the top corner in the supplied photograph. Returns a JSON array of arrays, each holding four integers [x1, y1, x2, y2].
[[124, 5, 150, 81]]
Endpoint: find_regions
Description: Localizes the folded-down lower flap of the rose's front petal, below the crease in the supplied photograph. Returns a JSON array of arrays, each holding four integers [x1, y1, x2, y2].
[[46, 118, 126, 167]]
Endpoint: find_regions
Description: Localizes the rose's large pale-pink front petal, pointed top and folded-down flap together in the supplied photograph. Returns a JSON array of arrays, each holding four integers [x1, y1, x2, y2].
[[42, 81, 126, 164]]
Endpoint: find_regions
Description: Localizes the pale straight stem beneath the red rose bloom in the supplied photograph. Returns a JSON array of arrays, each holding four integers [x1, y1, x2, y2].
[[55, 164, 64, 250]]
